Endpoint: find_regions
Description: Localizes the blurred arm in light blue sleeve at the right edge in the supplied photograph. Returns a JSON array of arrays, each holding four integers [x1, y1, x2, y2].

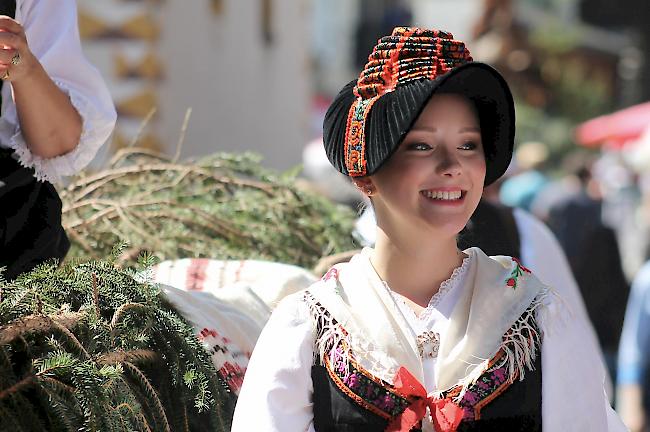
[[616, 264, 650, 432]]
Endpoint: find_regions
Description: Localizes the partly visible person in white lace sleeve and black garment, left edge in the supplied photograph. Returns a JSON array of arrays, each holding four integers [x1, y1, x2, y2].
[[0, 0, 116, 279]]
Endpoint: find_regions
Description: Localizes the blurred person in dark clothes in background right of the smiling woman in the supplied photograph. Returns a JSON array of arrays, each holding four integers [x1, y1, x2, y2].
[[547, 152, 629, 376]]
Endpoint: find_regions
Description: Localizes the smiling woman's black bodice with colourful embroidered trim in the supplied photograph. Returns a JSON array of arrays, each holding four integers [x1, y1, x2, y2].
[[311, 315, 542, 432]]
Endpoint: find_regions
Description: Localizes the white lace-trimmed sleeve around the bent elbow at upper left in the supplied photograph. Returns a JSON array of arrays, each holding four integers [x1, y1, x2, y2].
[[0, 0, 116, 183]]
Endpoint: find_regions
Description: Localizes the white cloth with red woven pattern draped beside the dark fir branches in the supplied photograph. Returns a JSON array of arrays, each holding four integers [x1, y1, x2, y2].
[[152, 258, 316, 394]]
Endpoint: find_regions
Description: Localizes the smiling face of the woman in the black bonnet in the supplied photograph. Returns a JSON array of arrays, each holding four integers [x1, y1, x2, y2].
[[369, 94, 485, 236]]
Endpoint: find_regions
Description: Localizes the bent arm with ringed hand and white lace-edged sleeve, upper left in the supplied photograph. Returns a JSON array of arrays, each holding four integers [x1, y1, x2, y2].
[[0, 0, 116, 182]]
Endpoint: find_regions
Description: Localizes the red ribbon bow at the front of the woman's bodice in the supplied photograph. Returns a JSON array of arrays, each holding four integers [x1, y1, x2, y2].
[[386, 367, 463, 432]]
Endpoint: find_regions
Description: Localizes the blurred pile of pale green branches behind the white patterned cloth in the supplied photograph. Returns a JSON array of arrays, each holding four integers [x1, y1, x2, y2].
[[61, 149, 355, 267]]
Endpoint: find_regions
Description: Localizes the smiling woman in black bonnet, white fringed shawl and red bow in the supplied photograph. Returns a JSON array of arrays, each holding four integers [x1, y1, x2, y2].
[[232, 27, 625, 432]]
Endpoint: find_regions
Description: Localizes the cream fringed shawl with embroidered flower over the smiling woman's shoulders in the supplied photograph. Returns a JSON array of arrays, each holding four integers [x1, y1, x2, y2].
[[306, 248, 550, 392]]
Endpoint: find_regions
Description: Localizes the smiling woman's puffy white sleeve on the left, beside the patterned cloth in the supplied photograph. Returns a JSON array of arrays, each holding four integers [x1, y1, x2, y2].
[[231, 293, 314, 432]]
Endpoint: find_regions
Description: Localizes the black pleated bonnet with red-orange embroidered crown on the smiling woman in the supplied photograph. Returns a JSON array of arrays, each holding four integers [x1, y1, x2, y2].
[[323, 27, 515, 185]]
